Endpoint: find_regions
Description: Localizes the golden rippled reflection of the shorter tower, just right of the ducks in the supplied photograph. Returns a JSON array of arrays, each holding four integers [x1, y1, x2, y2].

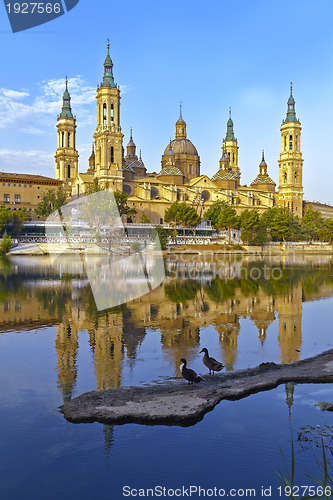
[[216, 313, 240, 370]]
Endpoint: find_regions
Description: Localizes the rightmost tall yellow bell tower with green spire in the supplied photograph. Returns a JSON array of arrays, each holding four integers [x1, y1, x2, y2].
[[279, 84, 303, 217]]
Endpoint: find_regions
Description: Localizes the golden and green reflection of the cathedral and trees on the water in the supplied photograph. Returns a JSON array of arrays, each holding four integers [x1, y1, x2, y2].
[[0, 256, 333, 404]]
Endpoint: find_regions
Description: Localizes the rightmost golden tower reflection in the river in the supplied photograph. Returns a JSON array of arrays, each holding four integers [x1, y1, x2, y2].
[[276, 284, 302, 363]]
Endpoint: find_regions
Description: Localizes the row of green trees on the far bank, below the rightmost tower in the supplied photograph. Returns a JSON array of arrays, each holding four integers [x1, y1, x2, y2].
[[205, 201, 333, 245]]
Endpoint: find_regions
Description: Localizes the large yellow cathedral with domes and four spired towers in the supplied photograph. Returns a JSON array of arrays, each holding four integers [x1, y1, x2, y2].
[[55, 44, 303, 224]]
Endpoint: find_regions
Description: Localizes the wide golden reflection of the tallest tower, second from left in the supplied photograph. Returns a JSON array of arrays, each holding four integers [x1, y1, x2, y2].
[[90, 314, 123, 390]]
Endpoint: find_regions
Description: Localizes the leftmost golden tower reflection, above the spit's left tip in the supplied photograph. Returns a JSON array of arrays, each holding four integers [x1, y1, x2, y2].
[[56, 323, 79, 402]]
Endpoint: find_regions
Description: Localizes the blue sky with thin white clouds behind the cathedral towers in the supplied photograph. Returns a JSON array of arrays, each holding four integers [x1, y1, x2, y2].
[[0, 0, 333, 205]]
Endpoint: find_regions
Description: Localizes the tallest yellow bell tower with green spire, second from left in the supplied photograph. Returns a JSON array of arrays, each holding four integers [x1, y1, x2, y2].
[[94, 42, 123, 190]]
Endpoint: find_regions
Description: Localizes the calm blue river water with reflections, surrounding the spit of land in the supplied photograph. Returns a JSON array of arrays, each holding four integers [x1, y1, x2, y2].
[[0, 256, 333, 500]]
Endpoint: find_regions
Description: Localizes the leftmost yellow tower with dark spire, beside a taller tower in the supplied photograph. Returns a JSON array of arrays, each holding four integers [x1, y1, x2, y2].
[[55, 77, 79, 193]]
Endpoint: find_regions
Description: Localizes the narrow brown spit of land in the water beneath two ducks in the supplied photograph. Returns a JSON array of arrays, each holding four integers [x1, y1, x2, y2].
[[61, 349, 333, 426]]
